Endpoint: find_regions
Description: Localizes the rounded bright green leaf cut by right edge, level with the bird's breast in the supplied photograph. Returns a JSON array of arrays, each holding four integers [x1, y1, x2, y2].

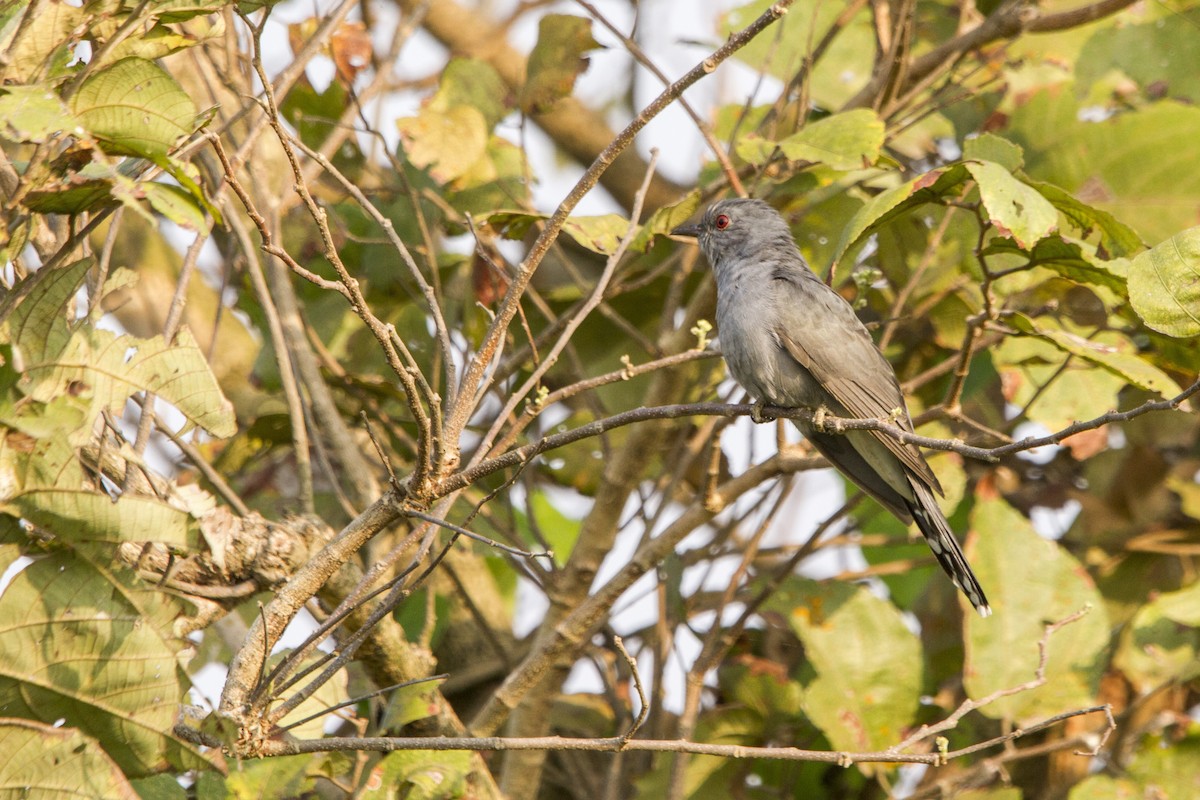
[[1129, 227, 1200, 338]]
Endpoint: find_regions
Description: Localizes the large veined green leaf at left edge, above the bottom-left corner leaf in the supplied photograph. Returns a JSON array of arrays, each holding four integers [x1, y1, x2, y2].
[[0, 546, 205, 777]]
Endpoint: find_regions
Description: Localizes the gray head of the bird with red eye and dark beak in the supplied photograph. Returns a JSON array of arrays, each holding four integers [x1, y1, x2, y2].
[[671, 199, 796, 269]]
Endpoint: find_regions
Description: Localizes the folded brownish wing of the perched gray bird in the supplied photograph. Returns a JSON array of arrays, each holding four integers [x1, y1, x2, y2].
[[775, 323, 942, 494]]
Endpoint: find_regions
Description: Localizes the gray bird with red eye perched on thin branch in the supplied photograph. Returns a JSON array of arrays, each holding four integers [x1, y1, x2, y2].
[[671, 199, 991, 616]]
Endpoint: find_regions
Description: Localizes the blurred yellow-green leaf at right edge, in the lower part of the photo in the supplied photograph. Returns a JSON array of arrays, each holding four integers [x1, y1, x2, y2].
[[1112, 583, 1200, 696]]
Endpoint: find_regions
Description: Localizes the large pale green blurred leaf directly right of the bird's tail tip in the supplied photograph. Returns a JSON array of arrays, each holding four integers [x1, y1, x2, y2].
[[962, 499, 1109, 723]]
